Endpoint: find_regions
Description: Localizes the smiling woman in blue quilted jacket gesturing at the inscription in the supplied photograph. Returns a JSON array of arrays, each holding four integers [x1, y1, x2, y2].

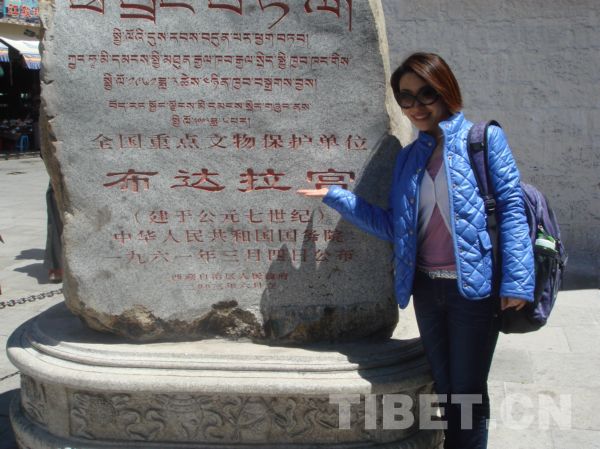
[[299, 53, 534, 449]]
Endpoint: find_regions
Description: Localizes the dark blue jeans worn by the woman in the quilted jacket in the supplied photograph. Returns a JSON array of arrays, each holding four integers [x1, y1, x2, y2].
[[413, 272, 498, 449]]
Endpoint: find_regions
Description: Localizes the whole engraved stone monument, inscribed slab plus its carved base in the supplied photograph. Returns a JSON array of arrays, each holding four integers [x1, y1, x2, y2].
[[9, 0, 440, 449]]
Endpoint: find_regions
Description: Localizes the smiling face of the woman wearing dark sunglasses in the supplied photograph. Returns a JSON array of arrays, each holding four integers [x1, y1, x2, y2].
[[399, 72, 451, 137]]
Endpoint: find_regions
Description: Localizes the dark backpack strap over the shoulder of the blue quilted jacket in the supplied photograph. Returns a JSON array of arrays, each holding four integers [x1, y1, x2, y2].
[[467, 120, 501, 280]]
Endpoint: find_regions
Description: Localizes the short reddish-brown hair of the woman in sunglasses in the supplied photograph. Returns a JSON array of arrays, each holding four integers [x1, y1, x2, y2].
[[390, 53, 462, 114]]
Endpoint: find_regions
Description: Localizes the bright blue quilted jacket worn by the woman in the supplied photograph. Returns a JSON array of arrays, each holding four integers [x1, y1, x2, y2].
[[323, 113, 535, 308]]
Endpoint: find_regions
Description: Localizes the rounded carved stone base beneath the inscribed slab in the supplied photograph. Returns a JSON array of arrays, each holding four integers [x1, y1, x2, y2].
[[8, 305, 442, 449]]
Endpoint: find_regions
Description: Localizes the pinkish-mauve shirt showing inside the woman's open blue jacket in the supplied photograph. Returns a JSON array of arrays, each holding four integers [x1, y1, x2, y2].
[[417, 153, 456, 271]]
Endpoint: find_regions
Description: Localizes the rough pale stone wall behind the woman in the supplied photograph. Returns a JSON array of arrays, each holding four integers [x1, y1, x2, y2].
[[383, 0, 600, 287]]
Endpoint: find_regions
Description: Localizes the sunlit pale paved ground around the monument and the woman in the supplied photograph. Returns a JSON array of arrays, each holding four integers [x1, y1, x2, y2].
[[0, 157, 600, 449]]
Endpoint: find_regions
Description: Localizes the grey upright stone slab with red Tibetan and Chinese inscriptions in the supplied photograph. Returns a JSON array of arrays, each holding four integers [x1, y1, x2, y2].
[[42, 0, 410, 343]]
